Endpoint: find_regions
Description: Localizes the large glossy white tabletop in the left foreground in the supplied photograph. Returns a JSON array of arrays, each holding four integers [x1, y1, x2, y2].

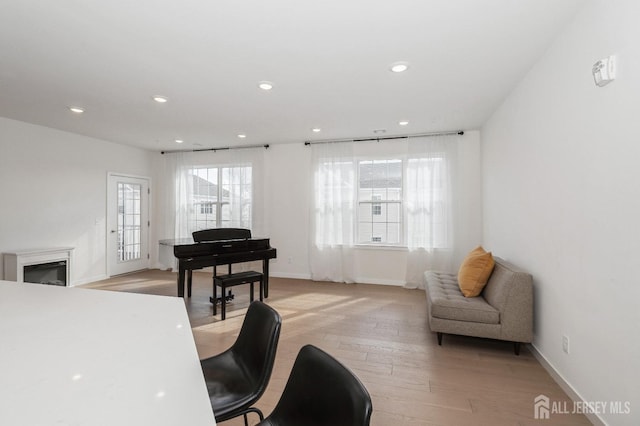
[[0, 281, 216, 426]]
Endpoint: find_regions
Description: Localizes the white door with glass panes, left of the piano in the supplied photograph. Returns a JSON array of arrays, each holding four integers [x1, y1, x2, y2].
[[107, 174, 149, 276]]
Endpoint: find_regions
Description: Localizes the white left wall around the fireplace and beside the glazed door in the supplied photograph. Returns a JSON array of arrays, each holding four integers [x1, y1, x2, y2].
[[0, 117, 152, 285]]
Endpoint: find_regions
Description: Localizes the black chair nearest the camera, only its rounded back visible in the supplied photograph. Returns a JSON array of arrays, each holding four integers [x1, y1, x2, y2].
[[258, 345, 373, 426]]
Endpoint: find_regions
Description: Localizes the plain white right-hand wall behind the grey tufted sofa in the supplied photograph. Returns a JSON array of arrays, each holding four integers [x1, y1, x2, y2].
[[482, 0, 640, 425]]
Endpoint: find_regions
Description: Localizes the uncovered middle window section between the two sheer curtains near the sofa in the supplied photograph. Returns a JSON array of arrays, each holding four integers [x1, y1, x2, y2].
[[357, 159, 402, 245]]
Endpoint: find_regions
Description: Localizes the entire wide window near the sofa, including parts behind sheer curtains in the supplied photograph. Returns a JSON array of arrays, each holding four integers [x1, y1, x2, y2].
[[314, 148, 451, 248]]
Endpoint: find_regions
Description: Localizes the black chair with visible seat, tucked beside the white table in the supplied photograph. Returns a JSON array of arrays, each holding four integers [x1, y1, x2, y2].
[[200, 300, 282, 426]]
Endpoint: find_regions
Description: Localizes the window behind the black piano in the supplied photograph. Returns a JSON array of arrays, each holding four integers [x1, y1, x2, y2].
[[189, 166, 252, 232]]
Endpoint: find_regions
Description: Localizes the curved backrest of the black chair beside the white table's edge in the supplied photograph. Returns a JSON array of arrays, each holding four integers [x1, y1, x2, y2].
[[230, 300, 282, 400]]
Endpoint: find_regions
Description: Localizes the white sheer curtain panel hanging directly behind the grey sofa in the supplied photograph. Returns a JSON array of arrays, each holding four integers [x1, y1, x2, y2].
[[404, 136, 459, 288]]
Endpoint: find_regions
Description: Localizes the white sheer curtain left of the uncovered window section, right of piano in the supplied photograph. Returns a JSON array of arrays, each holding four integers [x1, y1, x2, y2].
[[310, 143, 357, 283]]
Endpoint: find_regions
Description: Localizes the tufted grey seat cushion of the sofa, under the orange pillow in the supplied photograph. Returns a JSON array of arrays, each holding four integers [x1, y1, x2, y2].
[[425, 271, 500, 324]]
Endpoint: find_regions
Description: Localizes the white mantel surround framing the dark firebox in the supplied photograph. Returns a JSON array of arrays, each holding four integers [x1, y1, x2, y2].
[[4, 247, 73, 286]]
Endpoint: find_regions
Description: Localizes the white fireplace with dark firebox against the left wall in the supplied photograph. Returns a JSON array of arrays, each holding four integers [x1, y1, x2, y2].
[[4, 247, 73, 286]]
